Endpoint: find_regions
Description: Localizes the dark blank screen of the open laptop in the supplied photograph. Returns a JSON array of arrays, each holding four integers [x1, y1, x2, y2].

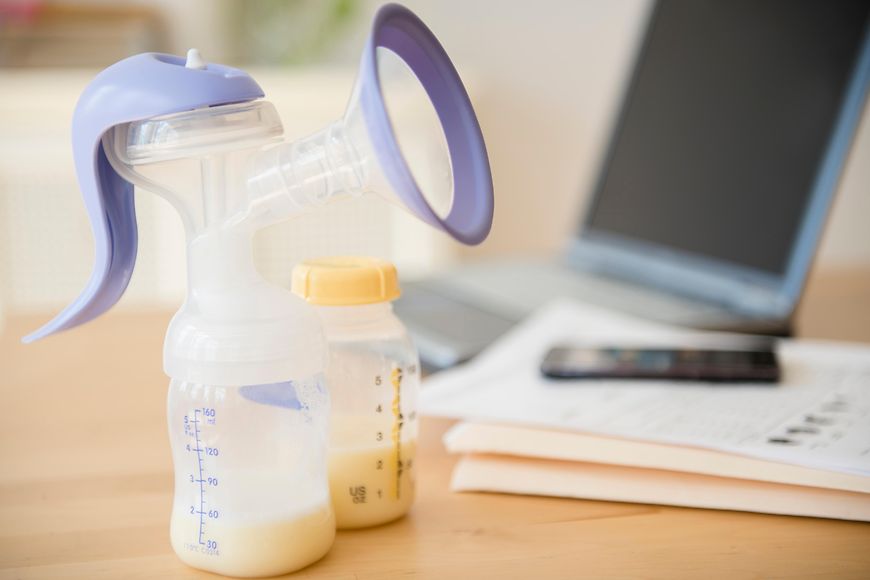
[[586, 0, 870, 276]]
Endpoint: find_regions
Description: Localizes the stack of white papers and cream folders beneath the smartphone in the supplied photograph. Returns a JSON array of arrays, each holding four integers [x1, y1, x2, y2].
[[421, 301, 870, 521]]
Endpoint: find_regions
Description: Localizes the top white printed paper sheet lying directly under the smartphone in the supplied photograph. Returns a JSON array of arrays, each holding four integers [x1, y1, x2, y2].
[[420, 301, 870, 475]]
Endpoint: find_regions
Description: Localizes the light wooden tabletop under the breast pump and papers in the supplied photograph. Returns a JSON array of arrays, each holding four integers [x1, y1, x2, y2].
[[0, 274, 870, 580]]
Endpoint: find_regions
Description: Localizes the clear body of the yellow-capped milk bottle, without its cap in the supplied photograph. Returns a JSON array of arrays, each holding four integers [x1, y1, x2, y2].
[[317, 302, 420, 528]]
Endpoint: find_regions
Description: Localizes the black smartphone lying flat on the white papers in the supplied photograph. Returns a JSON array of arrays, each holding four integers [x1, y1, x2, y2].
[[541, 346, 780, 383]]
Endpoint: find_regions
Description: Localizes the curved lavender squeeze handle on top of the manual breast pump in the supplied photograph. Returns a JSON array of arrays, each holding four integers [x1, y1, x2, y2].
[[23, 53, 263, 342]]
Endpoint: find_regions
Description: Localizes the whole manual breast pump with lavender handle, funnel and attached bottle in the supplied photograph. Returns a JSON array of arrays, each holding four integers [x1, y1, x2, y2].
[[25, 5, 493, 576]]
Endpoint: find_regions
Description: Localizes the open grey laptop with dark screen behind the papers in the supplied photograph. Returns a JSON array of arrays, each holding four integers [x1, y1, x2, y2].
[[396, 0, 870, 369]]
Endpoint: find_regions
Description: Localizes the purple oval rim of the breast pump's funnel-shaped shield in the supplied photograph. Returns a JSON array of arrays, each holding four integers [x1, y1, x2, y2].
[[358, 4, 494, 244]]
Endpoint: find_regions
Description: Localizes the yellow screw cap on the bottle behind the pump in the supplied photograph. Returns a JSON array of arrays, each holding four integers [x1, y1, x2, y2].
[[291, 256, 401, 306]]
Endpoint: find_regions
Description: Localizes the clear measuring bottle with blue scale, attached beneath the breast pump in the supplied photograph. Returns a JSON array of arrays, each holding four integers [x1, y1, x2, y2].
[[168, 376, 335, 576]]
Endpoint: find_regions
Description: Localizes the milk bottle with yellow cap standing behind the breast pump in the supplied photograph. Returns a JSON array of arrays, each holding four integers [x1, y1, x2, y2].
[[293, 257, 420, 528]]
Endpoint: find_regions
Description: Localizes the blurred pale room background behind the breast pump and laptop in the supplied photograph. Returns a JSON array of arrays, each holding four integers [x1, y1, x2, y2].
[[0, 0, 870, 316]]
